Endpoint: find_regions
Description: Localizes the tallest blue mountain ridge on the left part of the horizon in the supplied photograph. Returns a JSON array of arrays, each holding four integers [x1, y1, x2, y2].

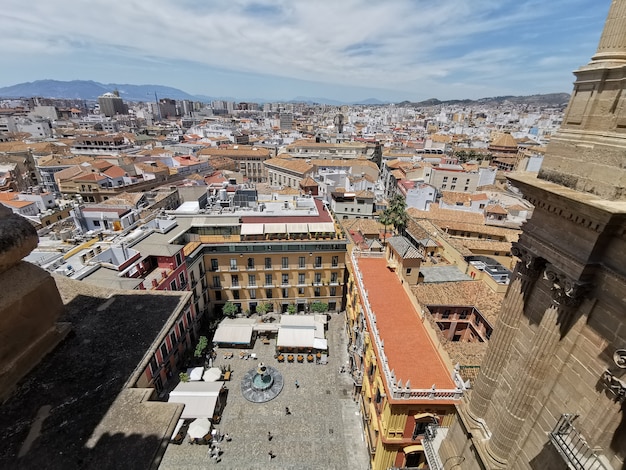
[[0, 80, 202, 101]]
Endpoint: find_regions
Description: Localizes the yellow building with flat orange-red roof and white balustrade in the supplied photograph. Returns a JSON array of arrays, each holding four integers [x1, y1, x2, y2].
[[346, 250, 465, 470]]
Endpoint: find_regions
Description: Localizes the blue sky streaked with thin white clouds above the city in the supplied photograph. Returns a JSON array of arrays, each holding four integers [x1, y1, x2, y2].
[[0, 0, 611, 102]]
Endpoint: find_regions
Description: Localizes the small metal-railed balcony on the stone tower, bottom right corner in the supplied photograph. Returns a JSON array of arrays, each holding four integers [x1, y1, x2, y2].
[[550, 414, 613, 470]]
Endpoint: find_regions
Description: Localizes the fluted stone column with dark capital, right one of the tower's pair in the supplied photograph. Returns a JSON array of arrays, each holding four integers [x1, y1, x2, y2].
[[487, 266, 584, 465]]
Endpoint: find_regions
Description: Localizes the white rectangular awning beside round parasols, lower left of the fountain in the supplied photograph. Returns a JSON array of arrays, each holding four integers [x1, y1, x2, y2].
[[168, 381, 223, 419]]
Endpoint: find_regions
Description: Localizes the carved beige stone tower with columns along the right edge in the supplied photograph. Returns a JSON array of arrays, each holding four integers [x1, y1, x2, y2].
[[439, 0, 626, 470]]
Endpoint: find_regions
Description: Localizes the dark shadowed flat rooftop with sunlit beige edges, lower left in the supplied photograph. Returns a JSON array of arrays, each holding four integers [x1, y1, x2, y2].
[[0, 276, 189, 469]]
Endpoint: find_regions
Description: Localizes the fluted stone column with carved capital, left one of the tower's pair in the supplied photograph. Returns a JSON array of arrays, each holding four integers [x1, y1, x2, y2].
[[468, 243, 545, 420]]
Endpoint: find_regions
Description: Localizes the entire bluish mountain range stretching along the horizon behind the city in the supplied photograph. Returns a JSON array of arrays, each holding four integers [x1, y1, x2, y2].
[[0, 80, 569, 107]]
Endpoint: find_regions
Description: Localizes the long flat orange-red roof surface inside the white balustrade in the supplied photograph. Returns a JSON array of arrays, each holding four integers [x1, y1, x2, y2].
[[358, 258, 455, 389]]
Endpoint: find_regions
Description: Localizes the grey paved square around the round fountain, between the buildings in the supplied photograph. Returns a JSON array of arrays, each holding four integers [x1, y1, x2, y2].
[[159, 314, 369, 470]]
